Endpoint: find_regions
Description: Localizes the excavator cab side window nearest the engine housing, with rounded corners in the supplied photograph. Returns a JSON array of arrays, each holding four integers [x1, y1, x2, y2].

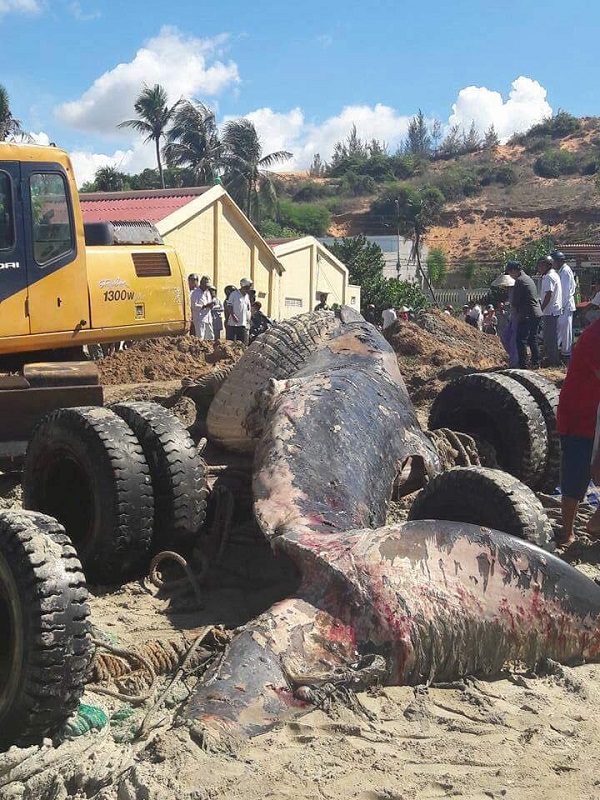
[[30, 172, 74, 267]]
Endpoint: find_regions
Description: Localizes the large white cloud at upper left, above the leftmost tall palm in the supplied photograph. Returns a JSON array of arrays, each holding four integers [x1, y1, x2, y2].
[[56, 26, 239, 135]]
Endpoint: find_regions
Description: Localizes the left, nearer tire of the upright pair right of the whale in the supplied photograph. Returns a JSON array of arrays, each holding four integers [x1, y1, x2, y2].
[[429, 373, 548, 489]]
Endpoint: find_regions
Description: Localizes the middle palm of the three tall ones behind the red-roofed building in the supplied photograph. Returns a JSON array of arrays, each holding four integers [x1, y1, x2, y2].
[[163, 100, 222, 185]]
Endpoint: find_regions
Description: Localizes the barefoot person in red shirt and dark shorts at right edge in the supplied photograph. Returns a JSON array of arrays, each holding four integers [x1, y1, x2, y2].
[[556, 319, 600, 545]]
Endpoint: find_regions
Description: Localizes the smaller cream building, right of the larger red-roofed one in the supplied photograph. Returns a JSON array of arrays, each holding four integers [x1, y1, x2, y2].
[[269, 236, 360, 319]]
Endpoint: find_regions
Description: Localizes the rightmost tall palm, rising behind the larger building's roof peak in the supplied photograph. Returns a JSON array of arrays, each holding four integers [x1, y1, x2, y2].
[[222, 119, 292, 221]]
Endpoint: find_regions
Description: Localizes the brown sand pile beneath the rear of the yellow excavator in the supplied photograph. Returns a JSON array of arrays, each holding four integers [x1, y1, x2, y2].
[[98, 336, 243, 386]]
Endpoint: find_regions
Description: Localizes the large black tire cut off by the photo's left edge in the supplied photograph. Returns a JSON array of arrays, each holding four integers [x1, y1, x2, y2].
[[0, 511, 92, 750]]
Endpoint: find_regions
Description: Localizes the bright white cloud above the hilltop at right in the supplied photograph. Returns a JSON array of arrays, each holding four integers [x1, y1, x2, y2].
[[448, 76, 552, 142]]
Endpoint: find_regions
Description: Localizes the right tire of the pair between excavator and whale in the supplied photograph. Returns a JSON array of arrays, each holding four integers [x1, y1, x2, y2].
[[111, 402, 208, 552]]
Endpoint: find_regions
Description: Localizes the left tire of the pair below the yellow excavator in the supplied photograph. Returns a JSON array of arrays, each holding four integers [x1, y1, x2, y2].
[[23, 407, 153, 584]]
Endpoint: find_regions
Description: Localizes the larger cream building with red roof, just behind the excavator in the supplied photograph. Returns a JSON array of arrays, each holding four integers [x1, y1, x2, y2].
[[80, 186, 283, 319]]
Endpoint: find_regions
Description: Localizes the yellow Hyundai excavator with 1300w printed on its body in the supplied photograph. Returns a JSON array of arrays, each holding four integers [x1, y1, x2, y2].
[[0, 143, 189, 469]]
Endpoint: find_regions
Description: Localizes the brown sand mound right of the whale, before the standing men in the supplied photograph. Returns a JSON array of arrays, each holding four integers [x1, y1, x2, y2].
[[386, 309, 507, 404]]
